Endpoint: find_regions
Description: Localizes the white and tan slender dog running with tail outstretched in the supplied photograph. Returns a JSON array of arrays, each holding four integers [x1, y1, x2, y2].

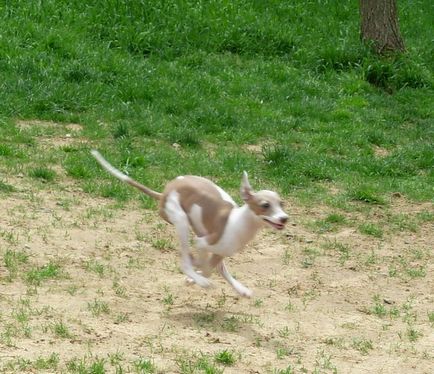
[[92, 150, 288, 297]]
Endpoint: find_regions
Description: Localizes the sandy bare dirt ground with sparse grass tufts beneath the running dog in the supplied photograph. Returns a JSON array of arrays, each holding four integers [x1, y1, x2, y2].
[[0, 124, 434, 373]]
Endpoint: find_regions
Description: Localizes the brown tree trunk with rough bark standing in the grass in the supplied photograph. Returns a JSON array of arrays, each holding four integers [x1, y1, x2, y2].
[[360, 0, 405, 54]]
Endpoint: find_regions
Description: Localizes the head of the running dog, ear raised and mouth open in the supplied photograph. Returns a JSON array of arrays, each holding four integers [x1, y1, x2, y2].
[[241, 172, 288, 230]]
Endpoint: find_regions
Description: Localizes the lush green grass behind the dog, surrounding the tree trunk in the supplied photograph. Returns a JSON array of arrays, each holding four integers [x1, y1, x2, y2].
[[0, 0, 434, 205]]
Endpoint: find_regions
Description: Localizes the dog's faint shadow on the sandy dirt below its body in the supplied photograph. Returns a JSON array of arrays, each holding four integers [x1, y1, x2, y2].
[[166, 304, 262, 341]]
